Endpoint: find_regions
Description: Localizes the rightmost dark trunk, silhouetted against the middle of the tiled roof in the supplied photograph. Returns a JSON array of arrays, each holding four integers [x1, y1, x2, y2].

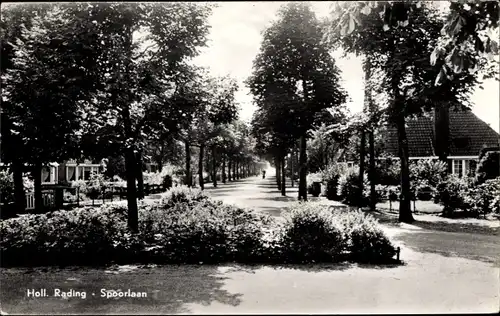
[[434, 104, 450, 162]]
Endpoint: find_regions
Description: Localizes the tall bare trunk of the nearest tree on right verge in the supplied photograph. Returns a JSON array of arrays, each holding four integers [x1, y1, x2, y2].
[[396, 114, 414, 223]]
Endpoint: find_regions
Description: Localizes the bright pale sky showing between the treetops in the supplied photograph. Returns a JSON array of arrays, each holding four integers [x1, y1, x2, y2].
[[194, 1, 500, 132]]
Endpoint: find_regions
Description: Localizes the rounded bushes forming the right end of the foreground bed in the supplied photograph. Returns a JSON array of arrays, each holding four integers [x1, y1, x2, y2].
[[278, 202, 396, 263]]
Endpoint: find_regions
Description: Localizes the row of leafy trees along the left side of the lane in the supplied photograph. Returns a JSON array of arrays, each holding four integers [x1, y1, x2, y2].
[[0, 2, 262, 231]]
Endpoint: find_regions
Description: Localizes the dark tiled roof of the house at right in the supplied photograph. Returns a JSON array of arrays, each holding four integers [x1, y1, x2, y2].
[[383, 109, 500, 157]]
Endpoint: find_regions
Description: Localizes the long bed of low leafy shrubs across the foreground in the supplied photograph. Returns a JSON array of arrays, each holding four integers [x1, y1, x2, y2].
[[0, 187, 395, 266]]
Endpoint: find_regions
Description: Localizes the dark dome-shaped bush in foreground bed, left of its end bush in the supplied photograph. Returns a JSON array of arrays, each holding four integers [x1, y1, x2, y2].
[[280, 203, 345, 263]]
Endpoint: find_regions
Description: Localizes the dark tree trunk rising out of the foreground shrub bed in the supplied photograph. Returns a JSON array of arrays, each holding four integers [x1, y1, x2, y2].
[[125, 147, 139, 233]]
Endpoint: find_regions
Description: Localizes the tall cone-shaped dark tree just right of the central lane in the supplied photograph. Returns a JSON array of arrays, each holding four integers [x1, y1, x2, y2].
[[247, 3, 346, 200]]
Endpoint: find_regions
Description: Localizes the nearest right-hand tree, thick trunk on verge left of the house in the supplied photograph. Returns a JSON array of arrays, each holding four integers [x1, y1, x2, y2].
[[324, 2, 484, 222]]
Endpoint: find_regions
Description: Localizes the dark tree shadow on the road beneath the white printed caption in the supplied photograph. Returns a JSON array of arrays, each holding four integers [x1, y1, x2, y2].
[[0, 265, 242, 315]]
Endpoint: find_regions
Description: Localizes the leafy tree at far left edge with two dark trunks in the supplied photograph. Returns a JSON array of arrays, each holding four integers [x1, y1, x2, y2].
[[2, 4, 105, 211]]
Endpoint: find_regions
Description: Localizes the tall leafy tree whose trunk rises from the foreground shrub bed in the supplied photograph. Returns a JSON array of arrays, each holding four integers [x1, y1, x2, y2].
[[76, 3, 211, 231]]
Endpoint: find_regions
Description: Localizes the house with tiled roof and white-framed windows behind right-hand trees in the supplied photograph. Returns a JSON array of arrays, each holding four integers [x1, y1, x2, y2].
[[382, 109, 500, 177]]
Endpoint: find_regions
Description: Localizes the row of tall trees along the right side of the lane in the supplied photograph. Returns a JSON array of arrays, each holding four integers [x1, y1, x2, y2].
[[248, 1, 498, 222]]
